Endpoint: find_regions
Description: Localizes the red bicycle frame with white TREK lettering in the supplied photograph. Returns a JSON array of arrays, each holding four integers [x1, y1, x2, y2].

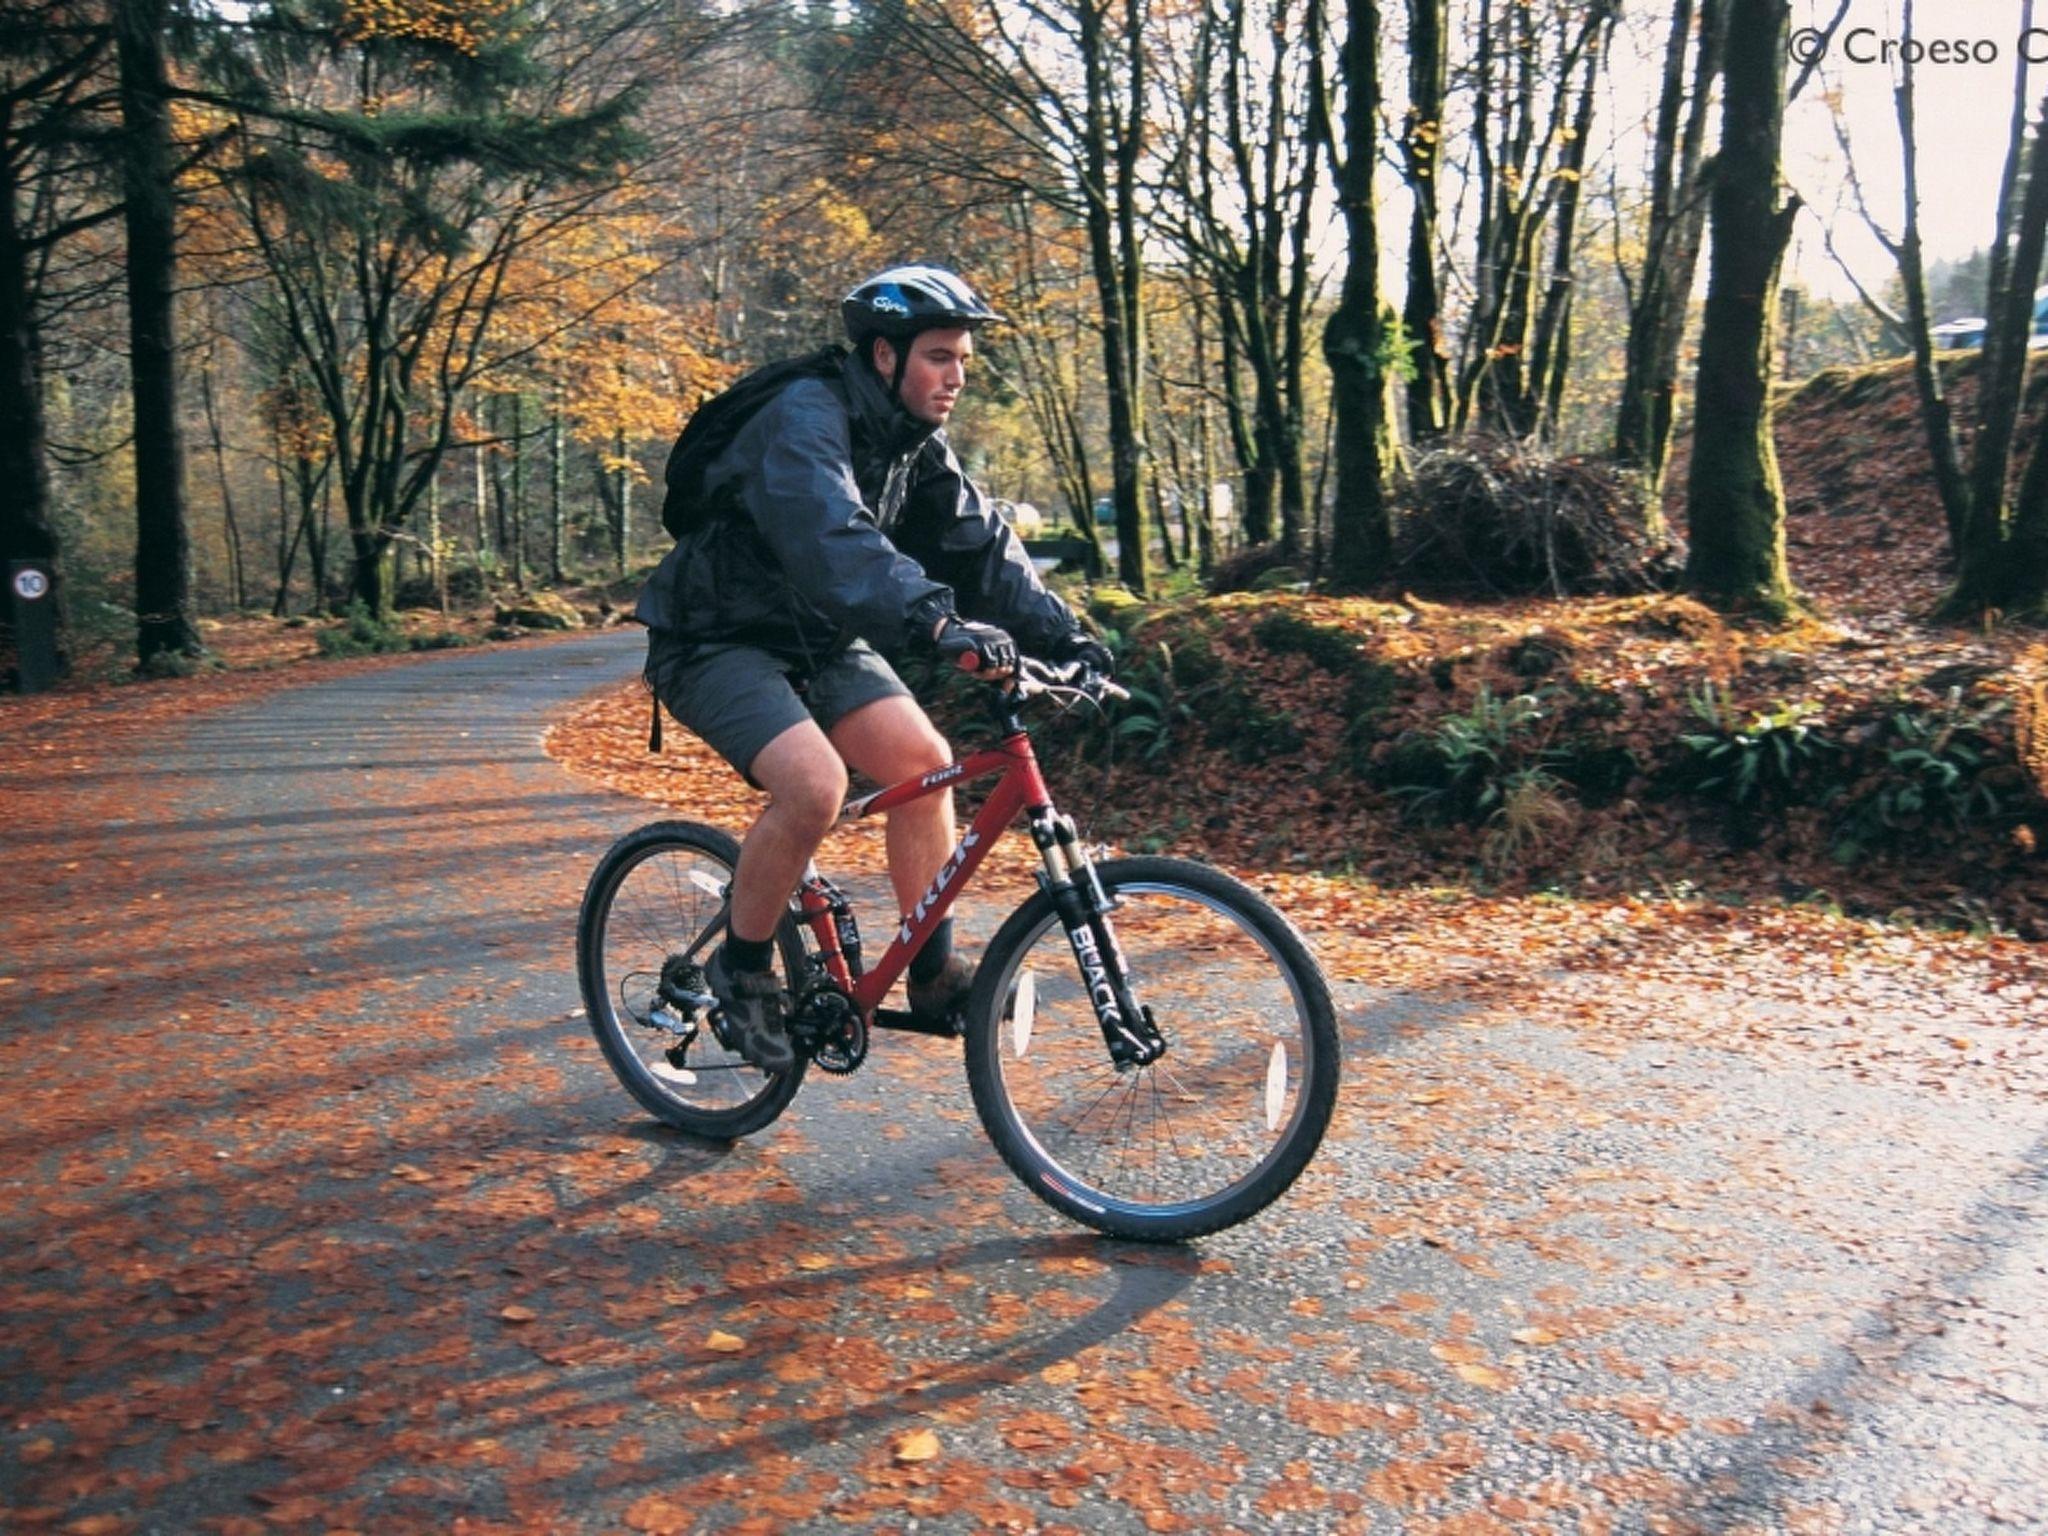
[[795, 731, 1057, 1020]]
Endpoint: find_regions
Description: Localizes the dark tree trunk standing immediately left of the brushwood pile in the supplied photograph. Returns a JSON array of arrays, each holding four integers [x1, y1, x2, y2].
[[1323, 0, 1393, 590]]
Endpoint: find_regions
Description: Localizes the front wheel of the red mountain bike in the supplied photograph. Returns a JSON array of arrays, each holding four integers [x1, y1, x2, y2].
[[967, 858, 1339, 1241]]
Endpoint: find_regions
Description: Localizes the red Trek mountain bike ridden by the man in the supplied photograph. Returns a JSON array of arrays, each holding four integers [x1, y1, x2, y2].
[[575, 659, 1339, 1241]]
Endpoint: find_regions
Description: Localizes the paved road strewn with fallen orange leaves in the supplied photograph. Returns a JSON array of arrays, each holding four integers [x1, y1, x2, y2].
[[0, 637, 2048, 1532]]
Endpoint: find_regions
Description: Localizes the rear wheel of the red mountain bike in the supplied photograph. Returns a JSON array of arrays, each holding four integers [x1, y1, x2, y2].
[[575, 821, 809, 1141]]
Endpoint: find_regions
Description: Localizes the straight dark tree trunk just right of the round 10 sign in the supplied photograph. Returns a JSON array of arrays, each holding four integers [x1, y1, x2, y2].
[[115, 0, 201, 670]]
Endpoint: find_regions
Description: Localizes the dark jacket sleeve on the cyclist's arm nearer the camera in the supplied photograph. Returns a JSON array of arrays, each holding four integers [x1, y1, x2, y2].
[[735, 383, 952, 649]]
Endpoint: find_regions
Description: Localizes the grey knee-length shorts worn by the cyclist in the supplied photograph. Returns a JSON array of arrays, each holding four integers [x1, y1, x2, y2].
[[647, 637, 911, 784]]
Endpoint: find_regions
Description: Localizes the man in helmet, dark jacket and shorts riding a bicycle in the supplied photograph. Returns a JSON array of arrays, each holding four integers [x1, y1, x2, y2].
[[635, 266, 1110, 1071]]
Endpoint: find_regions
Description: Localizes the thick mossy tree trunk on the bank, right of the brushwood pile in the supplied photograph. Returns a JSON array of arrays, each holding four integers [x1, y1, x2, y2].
[[1686, 0, 1798, 610]]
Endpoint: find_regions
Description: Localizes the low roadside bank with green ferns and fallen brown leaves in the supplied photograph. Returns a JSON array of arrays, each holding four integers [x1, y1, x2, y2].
[[991, 594, 2048, 936]]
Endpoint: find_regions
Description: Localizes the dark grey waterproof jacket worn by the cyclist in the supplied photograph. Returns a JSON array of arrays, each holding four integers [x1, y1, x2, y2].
[[635, 356, 1075, 666]]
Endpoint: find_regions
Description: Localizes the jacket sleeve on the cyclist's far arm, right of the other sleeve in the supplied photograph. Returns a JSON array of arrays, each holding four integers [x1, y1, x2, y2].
[[903, 436, 1079, 653]]
